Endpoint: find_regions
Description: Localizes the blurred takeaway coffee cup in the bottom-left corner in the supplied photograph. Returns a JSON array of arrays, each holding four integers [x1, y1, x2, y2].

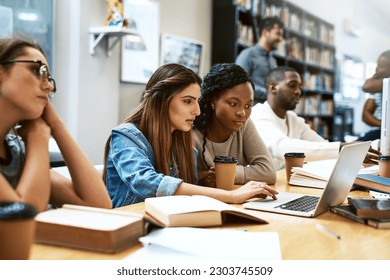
[[0, 202, 37, 260]]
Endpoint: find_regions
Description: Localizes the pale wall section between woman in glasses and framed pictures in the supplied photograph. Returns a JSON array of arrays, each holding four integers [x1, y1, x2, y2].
[[54, 0, 125, 164]]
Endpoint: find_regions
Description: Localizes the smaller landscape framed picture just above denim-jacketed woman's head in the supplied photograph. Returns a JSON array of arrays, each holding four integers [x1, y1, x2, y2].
[[160, 33, 204, 75]]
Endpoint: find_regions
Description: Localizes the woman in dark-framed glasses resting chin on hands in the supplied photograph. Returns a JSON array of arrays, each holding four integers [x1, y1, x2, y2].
[[0, 38, 111, 211]]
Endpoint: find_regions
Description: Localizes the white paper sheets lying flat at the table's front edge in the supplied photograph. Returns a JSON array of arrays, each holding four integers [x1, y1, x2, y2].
[[127, 227, 281, 260]]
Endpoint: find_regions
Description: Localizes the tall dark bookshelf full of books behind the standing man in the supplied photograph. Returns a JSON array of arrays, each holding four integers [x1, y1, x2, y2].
[[211, 0, 336, 141]]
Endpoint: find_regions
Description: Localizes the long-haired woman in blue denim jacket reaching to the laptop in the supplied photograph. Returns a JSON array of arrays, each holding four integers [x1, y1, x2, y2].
[[103, 64, 277, 207]]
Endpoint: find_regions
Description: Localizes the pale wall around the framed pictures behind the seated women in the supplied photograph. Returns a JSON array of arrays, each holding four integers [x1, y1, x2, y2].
[[54, 0, 211, 164]]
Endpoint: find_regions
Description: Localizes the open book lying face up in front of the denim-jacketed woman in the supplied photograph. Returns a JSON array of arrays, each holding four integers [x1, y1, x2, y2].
[[145, 195, 267, 227]]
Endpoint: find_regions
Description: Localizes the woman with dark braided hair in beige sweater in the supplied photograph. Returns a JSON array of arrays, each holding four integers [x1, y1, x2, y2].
[[193, 63, 276, 187]]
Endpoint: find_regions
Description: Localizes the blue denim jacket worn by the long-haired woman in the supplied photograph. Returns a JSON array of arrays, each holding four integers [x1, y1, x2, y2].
[[106, 123, 197, 208]]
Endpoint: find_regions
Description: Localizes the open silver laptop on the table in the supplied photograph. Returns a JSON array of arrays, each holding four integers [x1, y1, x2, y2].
[[243, 141, 371, 217]]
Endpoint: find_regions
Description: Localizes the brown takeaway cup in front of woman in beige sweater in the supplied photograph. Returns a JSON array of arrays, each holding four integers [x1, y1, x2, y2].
[[214, 156, 238, 190]]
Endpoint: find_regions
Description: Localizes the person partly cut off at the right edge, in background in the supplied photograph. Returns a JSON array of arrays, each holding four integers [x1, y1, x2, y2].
[[358, 50, 390, 141]]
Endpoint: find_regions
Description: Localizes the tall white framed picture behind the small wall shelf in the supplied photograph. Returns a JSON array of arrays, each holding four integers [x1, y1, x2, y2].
[[121, 0, 160, 83]]
